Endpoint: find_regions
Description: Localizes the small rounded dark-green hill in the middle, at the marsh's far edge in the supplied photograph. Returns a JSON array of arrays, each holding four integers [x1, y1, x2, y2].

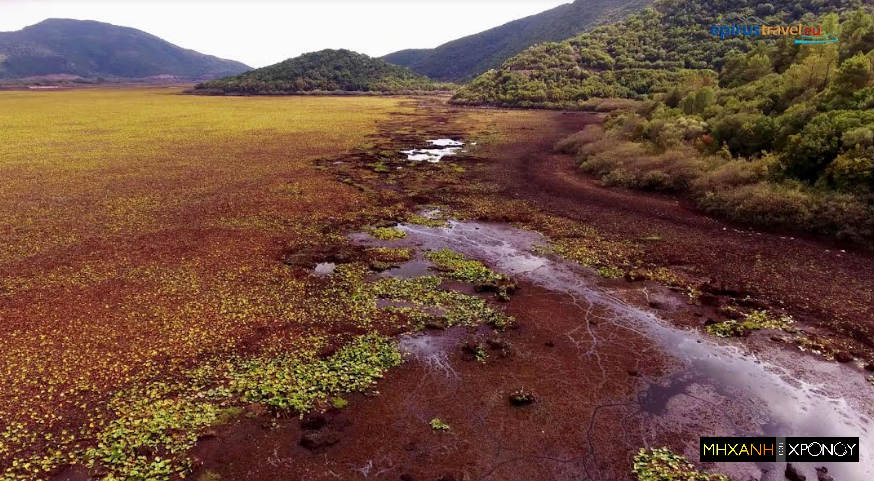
[[194, 49, 445, 95]]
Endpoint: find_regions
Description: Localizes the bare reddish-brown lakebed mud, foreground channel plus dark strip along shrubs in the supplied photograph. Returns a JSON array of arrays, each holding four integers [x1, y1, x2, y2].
[[194, 98, 874, 479]]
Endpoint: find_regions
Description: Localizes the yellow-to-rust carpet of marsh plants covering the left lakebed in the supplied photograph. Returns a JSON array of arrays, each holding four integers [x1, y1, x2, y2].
[[0, 89, 409, 465]]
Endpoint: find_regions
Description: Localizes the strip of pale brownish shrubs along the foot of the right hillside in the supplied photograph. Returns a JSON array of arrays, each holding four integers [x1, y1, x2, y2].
[[580, 131, 874, 241]]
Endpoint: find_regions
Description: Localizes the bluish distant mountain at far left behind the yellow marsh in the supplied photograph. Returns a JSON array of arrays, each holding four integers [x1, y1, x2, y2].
[[0, 18, 249, 80]]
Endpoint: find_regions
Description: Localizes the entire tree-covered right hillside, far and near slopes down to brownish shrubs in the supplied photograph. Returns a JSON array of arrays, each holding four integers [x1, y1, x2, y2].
[[510, 1, 874, 240]]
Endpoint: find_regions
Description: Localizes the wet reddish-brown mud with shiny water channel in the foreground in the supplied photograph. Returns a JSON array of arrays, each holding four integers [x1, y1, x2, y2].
[[196, 221, 874, 480]]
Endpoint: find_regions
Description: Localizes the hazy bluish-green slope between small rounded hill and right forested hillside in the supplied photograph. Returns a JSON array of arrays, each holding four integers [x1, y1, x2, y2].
[[382, 0, 652, 81]]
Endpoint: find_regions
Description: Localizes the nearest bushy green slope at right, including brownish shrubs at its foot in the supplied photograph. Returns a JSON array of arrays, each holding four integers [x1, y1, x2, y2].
[[540, 5, 874, 243]]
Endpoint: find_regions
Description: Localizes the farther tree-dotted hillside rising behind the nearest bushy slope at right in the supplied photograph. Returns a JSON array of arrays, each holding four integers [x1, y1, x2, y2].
[[454, 0, 863, 107]]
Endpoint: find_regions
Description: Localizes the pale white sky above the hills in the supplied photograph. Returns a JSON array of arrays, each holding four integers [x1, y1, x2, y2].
[[0, 0, 570, 67]]
